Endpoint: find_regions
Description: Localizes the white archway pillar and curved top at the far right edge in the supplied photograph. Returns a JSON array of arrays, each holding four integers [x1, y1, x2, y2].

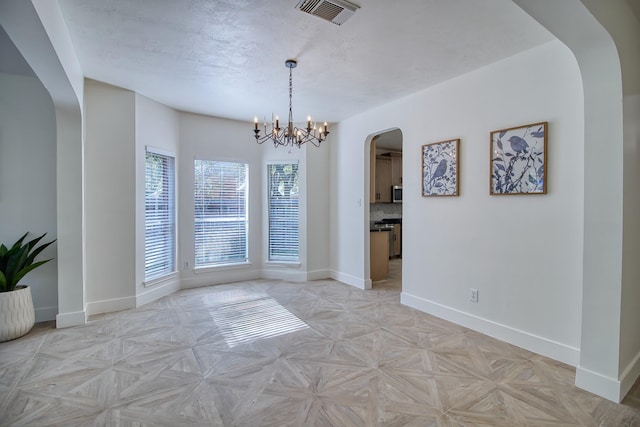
[[514, 0, 640, 402]]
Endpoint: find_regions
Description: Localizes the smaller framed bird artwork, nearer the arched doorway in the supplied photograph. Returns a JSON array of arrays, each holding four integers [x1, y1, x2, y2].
[[422, 139, 460, 197]]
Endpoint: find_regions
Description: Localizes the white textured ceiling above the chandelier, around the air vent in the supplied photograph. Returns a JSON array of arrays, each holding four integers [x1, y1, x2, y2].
[[59, 0, 553, 122]]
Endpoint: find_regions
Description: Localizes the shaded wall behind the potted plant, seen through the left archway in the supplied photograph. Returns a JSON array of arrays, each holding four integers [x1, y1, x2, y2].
[[0, 74, 58, 322]]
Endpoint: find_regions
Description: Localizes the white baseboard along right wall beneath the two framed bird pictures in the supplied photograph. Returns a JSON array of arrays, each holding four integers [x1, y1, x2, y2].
[[400, 292, 580, 366]]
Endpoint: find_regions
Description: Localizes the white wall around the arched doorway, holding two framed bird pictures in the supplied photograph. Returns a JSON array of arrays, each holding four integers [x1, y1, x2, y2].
[[331, 42, 584, 365]]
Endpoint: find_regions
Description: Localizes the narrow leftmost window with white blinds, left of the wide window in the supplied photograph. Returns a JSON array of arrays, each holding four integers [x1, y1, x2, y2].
[[144, 149, 176, 281]]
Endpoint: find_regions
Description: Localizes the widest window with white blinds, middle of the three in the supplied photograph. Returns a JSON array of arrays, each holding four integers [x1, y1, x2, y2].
[[194, 160, 249, 267]]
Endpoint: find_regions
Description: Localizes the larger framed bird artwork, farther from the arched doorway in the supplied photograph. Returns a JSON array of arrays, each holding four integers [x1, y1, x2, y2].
[[489, 122, 547, 195]]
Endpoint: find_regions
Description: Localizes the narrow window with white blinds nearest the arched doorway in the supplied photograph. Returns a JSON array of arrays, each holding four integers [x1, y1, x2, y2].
[[267, 163, 300, 261]]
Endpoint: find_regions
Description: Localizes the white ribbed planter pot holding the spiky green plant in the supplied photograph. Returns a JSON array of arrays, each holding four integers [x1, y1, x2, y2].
[[0, 286, 36, 342]]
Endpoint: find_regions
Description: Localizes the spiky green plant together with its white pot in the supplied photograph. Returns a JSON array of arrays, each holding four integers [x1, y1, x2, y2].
[[0, 232, 55, 342]]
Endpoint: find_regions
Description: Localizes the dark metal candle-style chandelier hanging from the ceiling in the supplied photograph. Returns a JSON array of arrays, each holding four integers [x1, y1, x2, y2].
[[253, 59, 329, 148]]
